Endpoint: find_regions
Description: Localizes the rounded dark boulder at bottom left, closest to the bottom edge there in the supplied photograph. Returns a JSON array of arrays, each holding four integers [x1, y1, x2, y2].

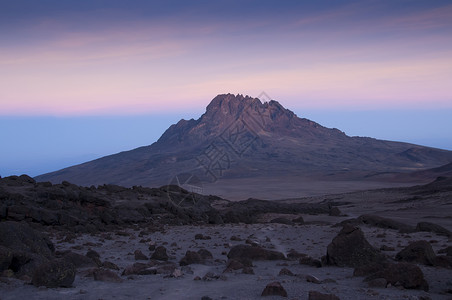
[[32, 259, 75, 288]]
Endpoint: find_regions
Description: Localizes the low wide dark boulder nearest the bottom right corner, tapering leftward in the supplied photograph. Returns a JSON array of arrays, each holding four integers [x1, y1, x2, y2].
[[365, 263, 428, 291]]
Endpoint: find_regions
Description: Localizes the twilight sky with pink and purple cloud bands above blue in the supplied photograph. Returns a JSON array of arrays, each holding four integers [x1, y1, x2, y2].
[[0, 0, 452, 176]]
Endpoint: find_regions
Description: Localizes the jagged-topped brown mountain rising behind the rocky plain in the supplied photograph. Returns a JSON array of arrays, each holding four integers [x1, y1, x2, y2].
[[36, 94, 452, 193]]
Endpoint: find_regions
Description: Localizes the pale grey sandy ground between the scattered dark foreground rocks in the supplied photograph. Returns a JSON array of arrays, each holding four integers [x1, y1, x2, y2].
[[0, 215, 452, 300]]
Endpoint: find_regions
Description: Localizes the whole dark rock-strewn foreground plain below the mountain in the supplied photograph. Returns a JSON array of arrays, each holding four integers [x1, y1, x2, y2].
[[0, 176, 452, 299]]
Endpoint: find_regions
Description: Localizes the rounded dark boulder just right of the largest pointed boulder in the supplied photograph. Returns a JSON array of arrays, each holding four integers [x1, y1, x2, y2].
[[395, 241, 436, 266]]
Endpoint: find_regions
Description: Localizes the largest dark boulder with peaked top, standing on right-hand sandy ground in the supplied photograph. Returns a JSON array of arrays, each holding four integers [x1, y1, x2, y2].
[[326, 225, 385, 267]]
